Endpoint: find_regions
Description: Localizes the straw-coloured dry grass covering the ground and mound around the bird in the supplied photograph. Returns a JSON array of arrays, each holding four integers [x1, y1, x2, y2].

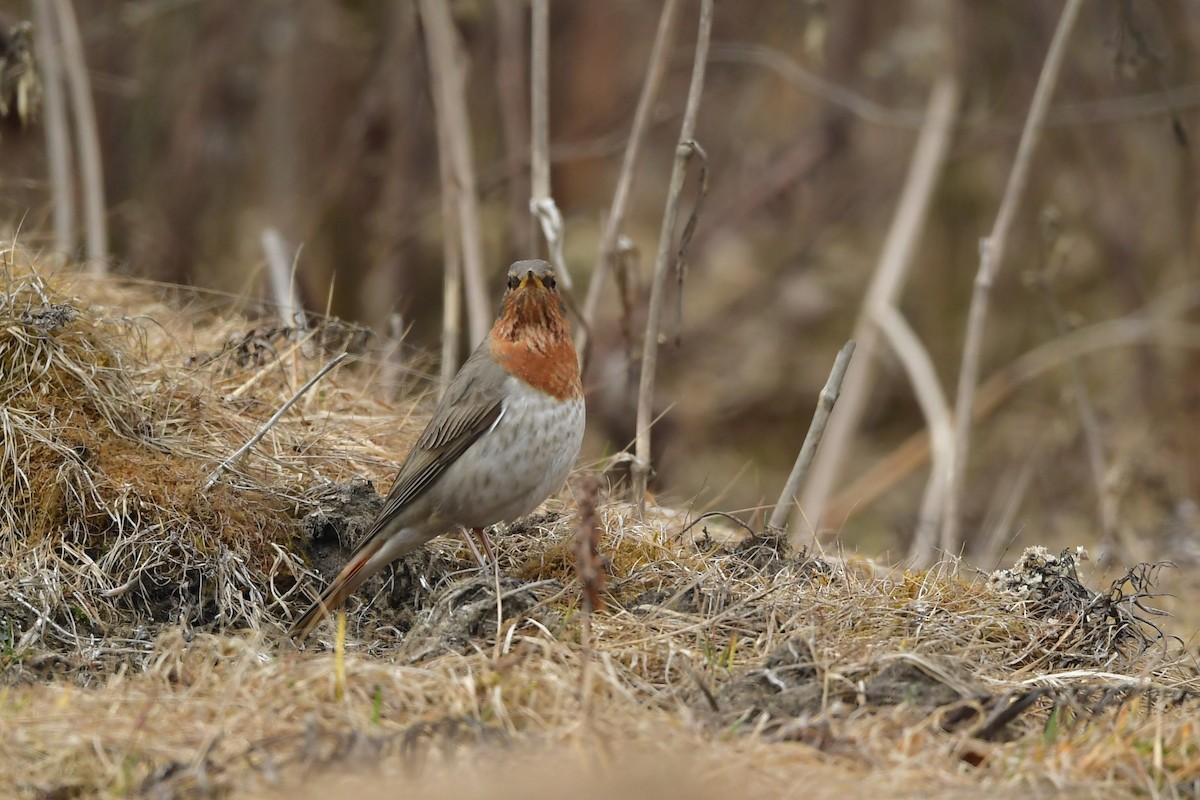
[[0, 249, 1200, 800]]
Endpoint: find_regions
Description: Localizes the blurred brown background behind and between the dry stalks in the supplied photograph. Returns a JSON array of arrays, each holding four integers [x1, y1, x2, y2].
[[0, 0, 1200, 568]]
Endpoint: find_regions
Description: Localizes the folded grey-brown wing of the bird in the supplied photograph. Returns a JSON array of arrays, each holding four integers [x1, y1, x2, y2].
[[364, 342, 508, 532]]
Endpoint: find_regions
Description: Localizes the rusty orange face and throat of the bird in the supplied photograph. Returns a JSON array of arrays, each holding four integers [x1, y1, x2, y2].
[[488, 289, 583, 401]]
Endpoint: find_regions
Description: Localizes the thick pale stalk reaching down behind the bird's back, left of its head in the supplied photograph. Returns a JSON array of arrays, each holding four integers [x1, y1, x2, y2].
[[419, 0, 492, 347]]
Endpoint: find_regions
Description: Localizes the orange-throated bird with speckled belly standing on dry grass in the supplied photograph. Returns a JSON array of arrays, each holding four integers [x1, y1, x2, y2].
[[289, 260, 584, 642]]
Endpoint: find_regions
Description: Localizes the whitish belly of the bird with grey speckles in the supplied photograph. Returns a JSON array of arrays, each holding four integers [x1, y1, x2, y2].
[[430, 378, 584, 528]]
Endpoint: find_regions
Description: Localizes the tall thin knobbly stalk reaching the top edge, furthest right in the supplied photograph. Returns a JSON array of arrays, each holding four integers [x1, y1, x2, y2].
[[942, 0, 1084, 551]]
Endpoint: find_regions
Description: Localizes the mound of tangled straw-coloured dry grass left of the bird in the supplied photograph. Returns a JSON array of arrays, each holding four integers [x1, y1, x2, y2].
[[0, 248, 422, 664]]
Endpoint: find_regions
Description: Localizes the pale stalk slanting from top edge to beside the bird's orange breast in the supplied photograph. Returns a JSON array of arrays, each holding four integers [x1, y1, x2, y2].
[[576, 0, 679, 371]]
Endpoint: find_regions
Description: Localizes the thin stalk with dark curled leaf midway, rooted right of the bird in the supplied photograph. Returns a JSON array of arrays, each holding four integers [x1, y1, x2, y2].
[[630, 0, 713, 509]]
